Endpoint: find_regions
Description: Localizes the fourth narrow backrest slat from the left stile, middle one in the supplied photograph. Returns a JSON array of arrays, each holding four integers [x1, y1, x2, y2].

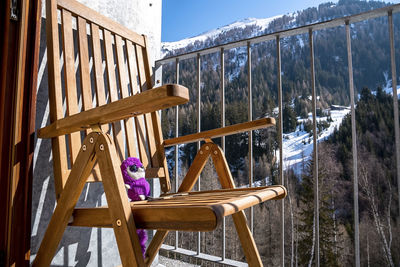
[[103, 30, 125, 161]]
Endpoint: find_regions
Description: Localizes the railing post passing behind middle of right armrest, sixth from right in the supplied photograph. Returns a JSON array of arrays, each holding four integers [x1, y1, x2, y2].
[[220, 47, 226, 261]]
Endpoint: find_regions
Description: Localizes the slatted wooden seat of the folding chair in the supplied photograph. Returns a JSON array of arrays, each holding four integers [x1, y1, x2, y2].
[[70, 185, 286, 231]]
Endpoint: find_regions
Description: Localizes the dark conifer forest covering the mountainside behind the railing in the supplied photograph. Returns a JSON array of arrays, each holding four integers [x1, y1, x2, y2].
[[162, 0, 400, 266]]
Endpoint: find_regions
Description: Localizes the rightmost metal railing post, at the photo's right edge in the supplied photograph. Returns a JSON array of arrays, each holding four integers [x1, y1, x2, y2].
[[388, 11, 400, 216]]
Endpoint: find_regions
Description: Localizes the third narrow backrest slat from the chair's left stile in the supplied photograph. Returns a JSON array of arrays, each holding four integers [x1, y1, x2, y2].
[[90, 23, 109, 133]]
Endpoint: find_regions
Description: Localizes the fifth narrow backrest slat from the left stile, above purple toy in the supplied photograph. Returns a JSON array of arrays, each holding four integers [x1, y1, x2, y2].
[[115, 35, 138, 157]]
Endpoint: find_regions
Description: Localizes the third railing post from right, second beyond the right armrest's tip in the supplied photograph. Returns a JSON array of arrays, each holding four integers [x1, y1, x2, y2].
[[308, 28, 319, 267]]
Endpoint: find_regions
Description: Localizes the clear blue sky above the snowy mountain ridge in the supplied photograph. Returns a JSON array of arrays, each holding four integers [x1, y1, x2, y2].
[[161, 0, 400, 42]]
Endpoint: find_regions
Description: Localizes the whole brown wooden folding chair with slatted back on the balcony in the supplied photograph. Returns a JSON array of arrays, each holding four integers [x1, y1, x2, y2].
[[33, 0, 286, 266]]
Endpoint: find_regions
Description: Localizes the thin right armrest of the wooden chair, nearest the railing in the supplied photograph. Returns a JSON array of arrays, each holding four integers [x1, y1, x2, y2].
[[164, 118, 275, 147]]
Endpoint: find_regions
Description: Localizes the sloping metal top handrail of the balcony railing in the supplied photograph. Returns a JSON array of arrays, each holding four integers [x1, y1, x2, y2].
[[156, 4, 400, 65]]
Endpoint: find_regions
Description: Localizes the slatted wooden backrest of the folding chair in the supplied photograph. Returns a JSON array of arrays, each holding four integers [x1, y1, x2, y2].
[[47, 0, 169, 198]]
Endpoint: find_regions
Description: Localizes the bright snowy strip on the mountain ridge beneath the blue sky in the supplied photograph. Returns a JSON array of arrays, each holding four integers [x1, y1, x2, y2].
[[161, 15, 283, 57]]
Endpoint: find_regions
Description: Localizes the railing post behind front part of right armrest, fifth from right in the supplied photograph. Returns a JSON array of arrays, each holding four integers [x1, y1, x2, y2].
[[247, 42, 254, 233]]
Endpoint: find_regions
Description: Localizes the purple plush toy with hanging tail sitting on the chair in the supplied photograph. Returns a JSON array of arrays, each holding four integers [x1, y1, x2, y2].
[[121, 157, 150, 257]]
